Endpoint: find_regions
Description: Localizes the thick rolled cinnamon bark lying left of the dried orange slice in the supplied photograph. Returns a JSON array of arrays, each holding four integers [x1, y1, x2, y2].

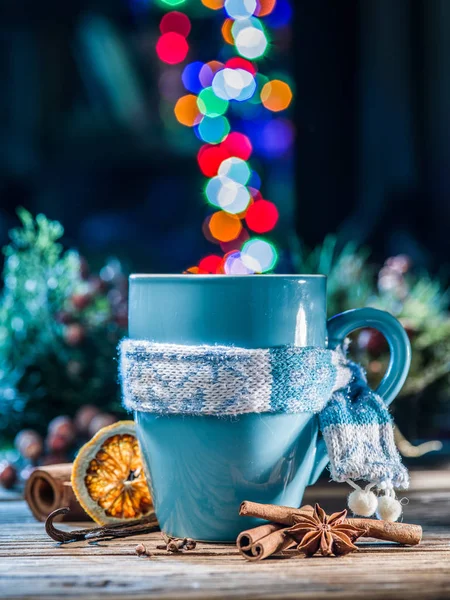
[[25, 463, 90, 521]]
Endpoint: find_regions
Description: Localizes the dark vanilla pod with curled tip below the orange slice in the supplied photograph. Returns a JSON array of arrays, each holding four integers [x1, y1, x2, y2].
[[45, 507, 159, 544]]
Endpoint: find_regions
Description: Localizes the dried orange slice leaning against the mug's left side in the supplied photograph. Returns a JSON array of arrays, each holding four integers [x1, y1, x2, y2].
[[72, 421, 153, 525]]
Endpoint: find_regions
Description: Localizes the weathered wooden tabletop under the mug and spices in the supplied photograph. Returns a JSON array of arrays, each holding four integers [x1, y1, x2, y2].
[[0, 471, 450, 600]]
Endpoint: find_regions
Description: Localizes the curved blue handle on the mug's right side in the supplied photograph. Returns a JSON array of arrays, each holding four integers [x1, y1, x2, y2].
[[308, 308, 411, 485]]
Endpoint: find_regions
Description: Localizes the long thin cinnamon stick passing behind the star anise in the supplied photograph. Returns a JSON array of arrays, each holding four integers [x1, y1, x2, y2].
[[239, 501, 422, 546]]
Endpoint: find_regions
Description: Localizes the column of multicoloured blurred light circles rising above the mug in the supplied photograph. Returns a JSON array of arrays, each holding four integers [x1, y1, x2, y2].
[[162, 0, 294, 275]]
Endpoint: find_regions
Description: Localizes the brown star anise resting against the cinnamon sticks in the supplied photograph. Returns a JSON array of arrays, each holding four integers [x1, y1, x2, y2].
[[286, 504, 365, 556]]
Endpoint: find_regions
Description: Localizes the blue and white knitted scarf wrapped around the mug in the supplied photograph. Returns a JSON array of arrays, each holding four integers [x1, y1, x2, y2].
[[119, 339, 408, 488]]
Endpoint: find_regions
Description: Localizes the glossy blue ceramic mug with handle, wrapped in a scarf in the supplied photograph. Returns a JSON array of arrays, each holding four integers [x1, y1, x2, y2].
[[129, 275, 411, 542]]
